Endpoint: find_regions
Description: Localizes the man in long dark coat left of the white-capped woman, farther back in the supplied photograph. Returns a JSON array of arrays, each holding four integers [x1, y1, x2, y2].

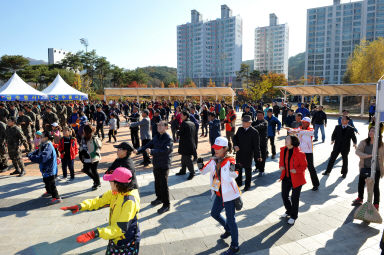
[[176, 110, 197, 180]]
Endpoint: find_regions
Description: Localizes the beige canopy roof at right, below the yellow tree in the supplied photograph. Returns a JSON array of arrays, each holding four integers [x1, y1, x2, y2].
[[277, 83, 376, 96]]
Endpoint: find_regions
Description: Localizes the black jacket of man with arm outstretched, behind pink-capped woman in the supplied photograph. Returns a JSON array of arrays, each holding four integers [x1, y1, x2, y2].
[[137, 133, 173, 170]]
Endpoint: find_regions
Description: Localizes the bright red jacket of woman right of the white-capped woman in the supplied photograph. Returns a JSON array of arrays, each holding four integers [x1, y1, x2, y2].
[[279, 146, 307, 188]]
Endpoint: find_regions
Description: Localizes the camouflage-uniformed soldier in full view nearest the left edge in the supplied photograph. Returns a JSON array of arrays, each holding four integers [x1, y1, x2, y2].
[[5, 117, 26, 177]]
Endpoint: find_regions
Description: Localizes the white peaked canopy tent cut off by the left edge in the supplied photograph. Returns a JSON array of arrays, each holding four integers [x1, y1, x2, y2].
[[0, 73, 47, 101]]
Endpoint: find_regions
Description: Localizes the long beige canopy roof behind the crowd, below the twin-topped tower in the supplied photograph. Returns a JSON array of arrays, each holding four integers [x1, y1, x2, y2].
[[104, 87, 235, 96]]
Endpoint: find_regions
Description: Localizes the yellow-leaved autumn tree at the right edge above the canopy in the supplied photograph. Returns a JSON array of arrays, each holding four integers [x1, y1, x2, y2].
[[344, 37, 384, 83]]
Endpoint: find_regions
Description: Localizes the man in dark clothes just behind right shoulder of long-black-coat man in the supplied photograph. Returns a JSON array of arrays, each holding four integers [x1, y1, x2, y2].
[[252, 110, 268, 177]]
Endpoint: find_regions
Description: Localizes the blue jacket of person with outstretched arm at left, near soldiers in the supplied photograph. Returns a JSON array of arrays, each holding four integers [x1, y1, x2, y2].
[[28, 142, 57, 178]]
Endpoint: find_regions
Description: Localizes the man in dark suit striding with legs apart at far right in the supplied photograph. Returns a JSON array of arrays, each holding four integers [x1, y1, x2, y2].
[[323, 116, 357, 178]]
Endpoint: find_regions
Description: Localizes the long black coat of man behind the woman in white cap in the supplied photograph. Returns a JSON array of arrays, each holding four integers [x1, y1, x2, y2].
[[233, 127, 261, 167]]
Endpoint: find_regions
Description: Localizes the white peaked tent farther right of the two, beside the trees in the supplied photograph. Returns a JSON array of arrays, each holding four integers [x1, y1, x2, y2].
[[43, 74, 88, 101]]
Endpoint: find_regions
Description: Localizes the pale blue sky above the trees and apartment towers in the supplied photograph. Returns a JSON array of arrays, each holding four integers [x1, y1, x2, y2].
[[0, 0, 342, 69]]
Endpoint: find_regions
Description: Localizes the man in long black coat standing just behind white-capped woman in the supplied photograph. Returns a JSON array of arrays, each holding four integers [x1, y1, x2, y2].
[[233, 115, 261, 191]]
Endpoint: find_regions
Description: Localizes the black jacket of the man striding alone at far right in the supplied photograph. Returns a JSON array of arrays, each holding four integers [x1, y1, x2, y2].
[[331, 125, 357, 152]]
